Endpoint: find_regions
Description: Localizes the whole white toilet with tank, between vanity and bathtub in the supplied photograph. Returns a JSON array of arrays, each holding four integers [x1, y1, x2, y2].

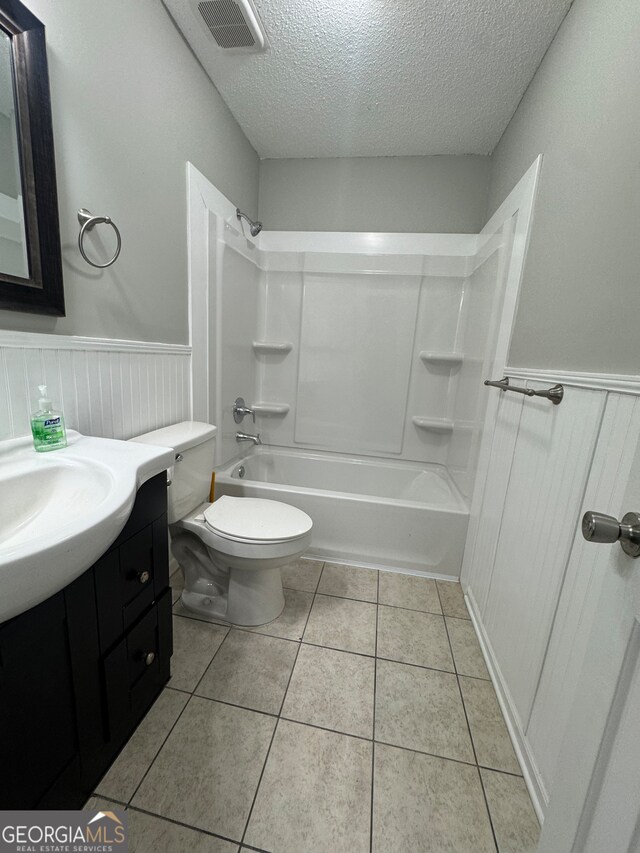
[[131, 421, 313, 625]]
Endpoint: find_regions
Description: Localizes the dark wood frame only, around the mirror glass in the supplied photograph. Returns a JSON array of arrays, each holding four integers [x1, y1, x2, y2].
[[0, 0, 65, 316]]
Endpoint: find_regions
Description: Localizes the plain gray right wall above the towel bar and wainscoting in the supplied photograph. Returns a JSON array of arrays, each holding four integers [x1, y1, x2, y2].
[[489, 0, 640, 374]]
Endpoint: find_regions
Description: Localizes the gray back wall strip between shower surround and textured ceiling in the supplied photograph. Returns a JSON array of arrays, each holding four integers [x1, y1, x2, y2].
[[260, 156, 489, 233]]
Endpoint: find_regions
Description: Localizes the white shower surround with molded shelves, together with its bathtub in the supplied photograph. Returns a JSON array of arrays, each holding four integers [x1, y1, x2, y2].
[[189, 167, 536, 577]]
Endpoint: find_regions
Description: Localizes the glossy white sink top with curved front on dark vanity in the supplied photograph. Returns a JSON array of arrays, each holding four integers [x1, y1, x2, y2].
[[0, 430, 173, 622]]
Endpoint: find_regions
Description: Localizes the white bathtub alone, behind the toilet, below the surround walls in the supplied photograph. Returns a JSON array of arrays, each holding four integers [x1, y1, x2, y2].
[[216, 446, 469, 578]]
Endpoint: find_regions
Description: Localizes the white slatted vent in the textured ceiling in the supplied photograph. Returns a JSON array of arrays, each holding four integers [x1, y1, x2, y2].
[[192, 0, 267, 53]]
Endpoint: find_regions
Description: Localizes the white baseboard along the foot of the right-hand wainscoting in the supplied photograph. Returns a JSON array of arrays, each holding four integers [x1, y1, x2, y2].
[[465, 589, 549, 824]]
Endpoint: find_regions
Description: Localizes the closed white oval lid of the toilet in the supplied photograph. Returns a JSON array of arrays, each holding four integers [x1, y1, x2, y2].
[[204, 495, 313, 542]]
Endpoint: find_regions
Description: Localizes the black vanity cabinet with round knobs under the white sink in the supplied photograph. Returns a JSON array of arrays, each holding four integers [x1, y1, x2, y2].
[[0, 472, 172, 809]]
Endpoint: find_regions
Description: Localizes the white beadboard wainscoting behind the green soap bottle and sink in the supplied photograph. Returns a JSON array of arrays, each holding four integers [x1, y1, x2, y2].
[[0, 332, 191, 440]]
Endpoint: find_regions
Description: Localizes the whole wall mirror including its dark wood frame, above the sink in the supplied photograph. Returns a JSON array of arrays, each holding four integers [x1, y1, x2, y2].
[[0, 0, 64, 316]]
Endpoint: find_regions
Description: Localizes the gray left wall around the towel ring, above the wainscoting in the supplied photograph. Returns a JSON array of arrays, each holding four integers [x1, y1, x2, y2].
[[0, 0, 259, 343]]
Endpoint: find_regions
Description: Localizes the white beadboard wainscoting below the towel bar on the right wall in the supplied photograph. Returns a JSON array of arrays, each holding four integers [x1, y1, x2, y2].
[[462, 369, 640, 818]]
